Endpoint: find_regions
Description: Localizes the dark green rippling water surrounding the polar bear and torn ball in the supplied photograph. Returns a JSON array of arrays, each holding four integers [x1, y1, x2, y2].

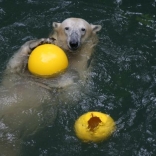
[[0, 0, 156, 156]]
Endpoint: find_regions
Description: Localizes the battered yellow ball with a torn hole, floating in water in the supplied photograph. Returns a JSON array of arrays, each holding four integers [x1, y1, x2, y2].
[[75, 112, 116, 142]]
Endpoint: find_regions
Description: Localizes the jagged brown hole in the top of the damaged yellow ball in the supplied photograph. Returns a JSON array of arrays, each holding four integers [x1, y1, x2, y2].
[[88, 114, 102, 131]]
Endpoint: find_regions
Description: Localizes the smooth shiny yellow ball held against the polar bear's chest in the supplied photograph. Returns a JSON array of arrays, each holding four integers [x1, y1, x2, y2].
[[28, 44, 68, 77]]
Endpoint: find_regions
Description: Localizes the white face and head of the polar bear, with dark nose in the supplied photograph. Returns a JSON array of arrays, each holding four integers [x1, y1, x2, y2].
[[53, 18, 101, 52]]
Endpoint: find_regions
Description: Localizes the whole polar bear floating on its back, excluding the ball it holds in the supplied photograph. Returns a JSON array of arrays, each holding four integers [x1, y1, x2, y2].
[[0, 18, 101, 156]]
